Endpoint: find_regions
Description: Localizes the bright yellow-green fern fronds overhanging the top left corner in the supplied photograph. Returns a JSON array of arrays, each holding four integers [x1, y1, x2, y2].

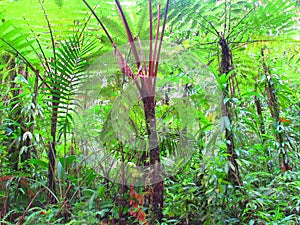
[[0, 0, 101, 53]]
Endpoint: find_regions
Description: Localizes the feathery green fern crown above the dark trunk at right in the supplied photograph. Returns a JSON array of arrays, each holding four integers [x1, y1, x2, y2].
[[169, 0, 296, 42]]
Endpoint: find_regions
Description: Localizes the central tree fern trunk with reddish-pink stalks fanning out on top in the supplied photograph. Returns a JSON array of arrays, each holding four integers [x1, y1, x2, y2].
[[83, 0, 170, 221]]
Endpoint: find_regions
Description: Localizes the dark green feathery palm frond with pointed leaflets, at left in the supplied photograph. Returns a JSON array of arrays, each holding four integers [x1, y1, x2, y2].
[[46, 35, 97, 134]]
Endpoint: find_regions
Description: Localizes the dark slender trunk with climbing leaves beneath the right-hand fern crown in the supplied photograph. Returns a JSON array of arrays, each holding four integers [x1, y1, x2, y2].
[[219, 38, 242, 186]]
